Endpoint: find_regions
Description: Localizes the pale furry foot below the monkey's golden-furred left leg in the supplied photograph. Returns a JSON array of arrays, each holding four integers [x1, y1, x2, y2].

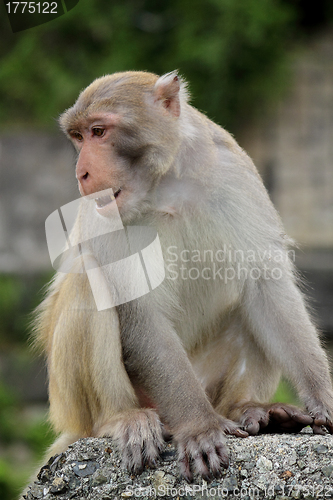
[[99, 409, 164, 474]]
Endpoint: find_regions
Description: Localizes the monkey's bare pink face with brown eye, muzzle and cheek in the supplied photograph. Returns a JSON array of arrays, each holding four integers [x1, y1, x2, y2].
[[67, 105, 179, 223]]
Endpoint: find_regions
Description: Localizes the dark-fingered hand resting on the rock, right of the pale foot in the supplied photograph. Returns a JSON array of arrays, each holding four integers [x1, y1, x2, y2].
[[174, 416, 248, 483]]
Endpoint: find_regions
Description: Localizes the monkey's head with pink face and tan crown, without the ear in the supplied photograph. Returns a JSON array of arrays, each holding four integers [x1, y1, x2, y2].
[[60, 74, 180, 222]]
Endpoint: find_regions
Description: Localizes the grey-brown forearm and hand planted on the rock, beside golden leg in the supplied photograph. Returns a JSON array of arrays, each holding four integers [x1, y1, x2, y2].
[[117, 297, 247, 481]]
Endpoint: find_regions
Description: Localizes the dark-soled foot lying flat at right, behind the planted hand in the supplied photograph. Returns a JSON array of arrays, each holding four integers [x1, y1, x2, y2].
[[239, 402, 313, 435]]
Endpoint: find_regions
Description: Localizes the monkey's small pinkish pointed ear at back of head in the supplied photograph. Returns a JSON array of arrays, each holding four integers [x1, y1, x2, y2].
[[154, 71, 180, 117]]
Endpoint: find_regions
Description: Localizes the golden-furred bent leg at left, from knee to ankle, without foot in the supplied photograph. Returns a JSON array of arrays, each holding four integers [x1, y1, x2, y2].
[[48, 274, 138, 437]]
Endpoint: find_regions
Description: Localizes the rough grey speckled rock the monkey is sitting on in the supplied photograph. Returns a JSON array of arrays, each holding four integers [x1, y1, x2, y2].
[[25, 431, 333, 500]]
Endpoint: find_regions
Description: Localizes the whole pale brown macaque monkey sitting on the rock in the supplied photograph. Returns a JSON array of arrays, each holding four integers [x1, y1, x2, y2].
[[36, 72, 333, 481]]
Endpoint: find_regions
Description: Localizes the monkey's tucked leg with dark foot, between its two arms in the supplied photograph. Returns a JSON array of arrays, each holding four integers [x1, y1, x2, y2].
[[193, 319, 312, 434]]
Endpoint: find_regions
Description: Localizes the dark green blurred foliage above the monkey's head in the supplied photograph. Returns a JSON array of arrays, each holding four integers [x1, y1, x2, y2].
[[0, 0, 298, 128]]
